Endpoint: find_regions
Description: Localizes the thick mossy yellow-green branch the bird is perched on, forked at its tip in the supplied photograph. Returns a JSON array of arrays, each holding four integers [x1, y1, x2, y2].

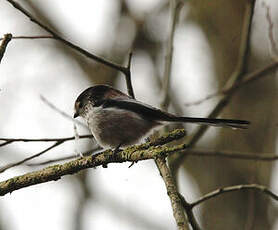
[[0, 130, 187, 196]]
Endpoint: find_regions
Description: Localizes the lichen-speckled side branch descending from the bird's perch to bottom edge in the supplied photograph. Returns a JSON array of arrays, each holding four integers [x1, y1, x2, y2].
[[155, 158, 189, 230]]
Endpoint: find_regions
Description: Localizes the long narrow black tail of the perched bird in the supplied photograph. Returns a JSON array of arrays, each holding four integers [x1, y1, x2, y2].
[[167, 116, 250, 129]]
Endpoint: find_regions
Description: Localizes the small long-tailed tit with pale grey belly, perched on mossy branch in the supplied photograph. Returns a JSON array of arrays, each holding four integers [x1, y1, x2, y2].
[[74, 85, 249, 149]]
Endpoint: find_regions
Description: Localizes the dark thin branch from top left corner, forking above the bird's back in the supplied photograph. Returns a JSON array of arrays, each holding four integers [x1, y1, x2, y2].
[[6, 0, 134, 96]]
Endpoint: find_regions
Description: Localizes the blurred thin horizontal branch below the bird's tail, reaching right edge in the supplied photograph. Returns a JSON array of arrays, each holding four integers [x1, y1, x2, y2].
[[184, 149, 278, 161]]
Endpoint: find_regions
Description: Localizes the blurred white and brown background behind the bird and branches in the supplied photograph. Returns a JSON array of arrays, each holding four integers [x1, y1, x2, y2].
[[0, 0, 278, 230]]
